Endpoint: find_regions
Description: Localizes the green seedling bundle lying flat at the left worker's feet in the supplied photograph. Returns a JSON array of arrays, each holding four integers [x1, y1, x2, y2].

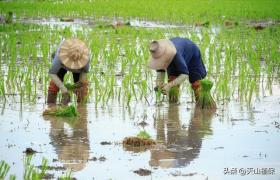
[[43, 105, 78, 117]]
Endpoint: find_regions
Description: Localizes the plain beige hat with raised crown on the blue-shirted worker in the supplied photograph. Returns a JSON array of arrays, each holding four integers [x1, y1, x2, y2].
[[149, 39, 177, 70]]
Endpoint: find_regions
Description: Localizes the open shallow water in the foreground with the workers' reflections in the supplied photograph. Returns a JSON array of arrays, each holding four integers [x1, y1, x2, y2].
[[0, 84, 280, 179]]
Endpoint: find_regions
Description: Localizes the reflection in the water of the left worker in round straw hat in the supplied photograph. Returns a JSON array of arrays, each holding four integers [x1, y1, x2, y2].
[[43, 105, 89, 171]]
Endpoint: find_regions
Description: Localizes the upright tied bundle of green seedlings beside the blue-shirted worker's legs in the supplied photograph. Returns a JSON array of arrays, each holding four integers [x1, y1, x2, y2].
[[196, 79, 216, 109]]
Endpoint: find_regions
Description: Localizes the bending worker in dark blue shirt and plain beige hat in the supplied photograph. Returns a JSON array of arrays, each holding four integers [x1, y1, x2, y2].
[[149, 37, 207, 100]]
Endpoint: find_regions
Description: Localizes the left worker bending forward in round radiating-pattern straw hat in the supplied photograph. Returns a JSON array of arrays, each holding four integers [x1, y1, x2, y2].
[[47, 38, 89, 105]]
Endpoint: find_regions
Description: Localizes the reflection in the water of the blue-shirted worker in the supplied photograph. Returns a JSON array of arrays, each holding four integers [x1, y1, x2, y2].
[[150, 105, 215, 168]]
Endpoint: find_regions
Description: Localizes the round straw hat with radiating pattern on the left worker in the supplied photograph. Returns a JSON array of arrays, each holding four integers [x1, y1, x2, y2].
[[59, 38, 89, 69]]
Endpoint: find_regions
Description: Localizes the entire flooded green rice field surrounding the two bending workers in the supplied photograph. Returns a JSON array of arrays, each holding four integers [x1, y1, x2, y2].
[[0, 0, 280, 179]]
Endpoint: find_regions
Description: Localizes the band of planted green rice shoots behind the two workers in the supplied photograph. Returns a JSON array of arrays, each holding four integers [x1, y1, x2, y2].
[[0, 21, 280, 105]]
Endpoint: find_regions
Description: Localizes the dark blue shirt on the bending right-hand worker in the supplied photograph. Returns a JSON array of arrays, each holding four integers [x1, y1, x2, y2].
[[164, 37, 207, 83]]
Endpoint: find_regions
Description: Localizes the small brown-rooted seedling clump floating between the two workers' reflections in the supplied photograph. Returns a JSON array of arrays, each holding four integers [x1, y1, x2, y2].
[[123, 131, 156, 147]]
